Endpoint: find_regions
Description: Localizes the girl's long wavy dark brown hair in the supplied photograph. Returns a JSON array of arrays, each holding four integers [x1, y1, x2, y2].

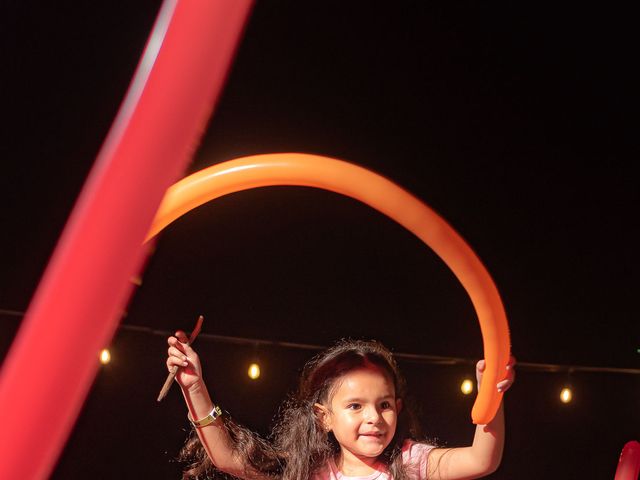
[[180, 339, 421, 480]]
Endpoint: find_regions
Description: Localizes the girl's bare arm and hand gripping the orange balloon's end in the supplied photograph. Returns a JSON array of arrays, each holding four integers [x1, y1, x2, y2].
[[428, 357, 515, 480]]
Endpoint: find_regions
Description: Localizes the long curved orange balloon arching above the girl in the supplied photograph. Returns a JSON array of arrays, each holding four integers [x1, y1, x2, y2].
[[147, 153, 510, 424]]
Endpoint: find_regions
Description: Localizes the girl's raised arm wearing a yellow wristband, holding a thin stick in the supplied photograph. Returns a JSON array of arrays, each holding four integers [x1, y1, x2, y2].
[[167, 331, 268, 479]]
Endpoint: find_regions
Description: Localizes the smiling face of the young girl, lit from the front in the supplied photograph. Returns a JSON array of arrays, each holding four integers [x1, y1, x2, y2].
[[316, 366, 401, 465]]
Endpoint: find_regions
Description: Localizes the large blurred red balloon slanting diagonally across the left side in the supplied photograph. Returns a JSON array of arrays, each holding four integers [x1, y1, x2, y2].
[[0, 0, 251, 479]]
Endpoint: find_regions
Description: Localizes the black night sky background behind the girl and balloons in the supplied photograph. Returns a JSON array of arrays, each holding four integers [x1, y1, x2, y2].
[[0, 0, 640, 479]]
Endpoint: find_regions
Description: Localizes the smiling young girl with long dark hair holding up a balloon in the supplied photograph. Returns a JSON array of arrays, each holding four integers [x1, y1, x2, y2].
[[167, 332, 515, 480]]
